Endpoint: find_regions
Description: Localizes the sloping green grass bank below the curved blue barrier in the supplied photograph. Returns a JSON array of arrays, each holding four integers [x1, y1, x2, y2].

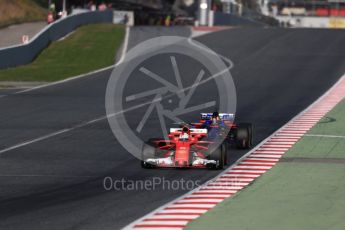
[[0, 24, 124, 82]]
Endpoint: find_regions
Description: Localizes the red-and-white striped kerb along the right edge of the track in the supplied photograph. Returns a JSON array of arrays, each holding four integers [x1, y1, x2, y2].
[[125, 76, 345, 230]]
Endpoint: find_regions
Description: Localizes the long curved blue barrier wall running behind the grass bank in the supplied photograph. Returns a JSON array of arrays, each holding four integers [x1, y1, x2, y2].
[[0, 11, 113, 69]]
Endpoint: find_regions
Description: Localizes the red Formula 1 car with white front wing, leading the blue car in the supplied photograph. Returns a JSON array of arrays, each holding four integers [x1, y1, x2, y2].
[[141, 125, 227, 169]]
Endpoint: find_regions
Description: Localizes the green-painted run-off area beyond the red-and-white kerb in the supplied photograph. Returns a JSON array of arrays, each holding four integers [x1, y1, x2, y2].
[[187, 101, 345, 230]]
